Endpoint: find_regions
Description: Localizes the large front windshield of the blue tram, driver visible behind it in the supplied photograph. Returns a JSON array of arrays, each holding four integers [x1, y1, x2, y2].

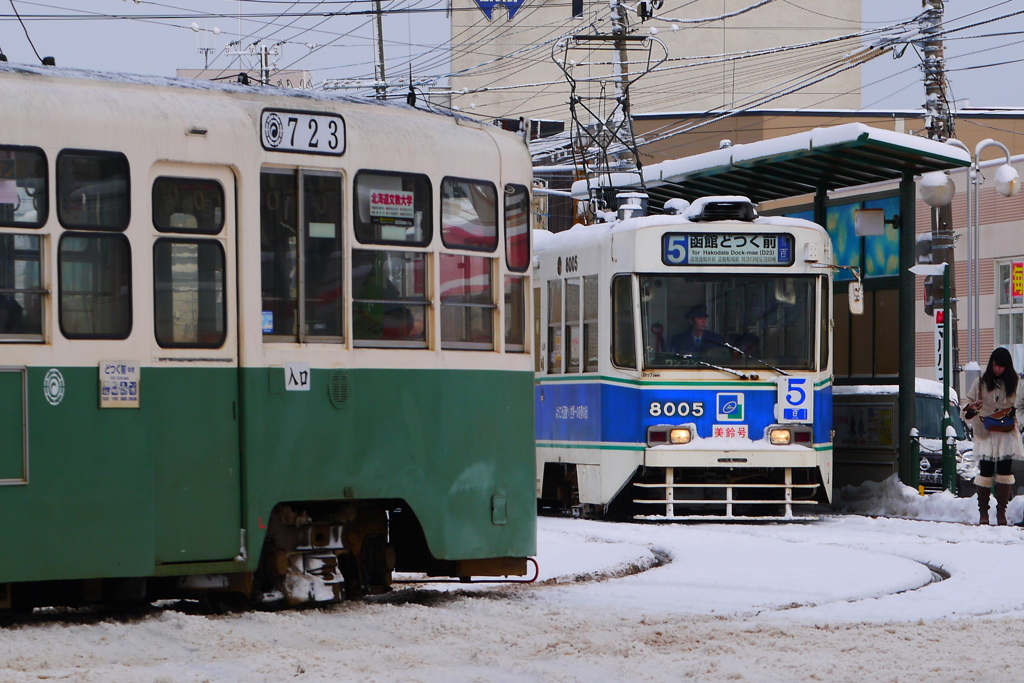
[[640, 273, 818, 370]]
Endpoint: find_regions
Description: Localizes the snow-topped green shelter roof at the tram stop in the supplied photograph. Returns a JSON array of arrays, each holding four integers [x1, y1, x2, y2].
[[572, 123, 971, 212]]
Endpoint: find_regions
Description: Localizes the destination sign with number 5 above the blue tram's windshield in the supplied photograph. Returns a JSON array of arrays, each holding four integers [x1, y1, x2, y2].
[[662, 232, 794, 265]]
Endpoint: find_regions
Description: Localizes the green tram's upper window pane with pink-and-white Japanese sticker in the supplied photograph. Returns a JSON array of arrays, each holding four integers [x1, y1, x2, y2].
[[354, 171, 433, 247]]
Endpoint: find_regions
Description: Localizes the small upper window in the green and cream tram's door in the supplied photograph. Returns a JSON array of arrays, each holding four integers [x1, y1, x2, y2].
[[153, 176, 224, 234]]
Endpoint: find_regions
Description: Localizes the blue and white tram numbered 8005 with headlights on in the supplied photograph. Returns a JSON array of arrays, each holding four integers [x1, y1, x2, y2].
[[534, 198, 833, 520]]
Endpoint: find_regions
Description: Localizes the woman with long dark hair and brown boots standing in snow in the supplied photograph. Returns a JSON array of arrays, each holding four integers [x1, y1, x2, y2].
[[964, 348, 1024, 525]]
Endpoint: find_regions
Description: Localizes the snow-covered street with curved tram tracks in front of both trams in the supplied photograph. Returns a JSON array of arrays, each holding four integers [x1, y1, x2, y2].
[[6, 481, 1024, 683]]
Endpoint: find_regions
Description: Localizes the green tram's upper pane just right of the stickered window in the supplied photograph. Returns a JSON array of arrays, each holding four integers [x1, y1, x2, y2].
[[441, 178, 498, 252]]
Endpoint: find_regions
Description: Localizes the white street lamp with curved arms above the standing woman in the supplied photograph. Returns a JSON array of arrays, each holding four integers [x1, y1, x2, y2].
[[942, 138, 1021, 393]]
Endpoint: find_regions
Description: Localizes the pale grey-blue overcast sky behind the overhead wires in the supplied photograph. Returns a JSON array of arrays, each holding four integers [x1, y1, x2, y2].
[[0, 0, 1024, 109]]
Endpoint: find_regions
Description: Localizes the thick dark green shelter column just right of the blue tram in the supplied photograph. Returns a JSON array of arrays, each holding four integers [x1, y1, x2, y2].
[[898, 171, 920, 488]]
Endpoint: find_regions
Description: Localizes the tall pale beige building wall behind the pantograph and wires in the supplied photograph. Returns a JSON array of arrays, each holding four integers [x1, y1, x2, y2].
[[451, 0, 860, 121]]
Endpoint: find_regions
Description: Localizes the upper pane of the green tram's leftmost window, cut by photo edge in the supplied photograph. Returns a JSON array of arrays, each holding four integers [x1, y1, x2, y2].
[[0, 146, 49, 227]]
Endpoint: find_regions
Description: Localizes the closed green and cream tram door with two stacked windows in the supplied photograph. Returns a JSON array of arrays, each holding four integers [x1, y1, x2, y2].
[[148, 164, 242, 564]]
